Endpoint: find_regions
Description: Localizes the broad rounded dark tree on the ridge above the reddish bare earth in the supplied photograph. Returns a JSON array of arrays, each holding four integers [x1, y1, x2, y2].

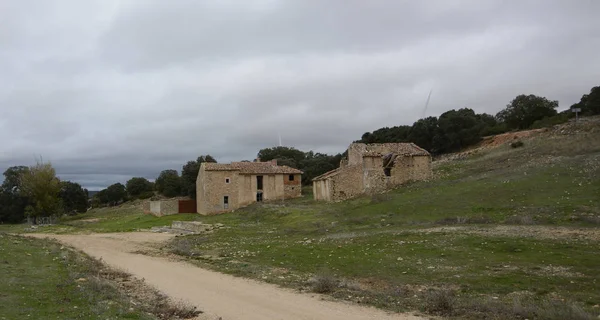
[[496, 94, 558, 129]]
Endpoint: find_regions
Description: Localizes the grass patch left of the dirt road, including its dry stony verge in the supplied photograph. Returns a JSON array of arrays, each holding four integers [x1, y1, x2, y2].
[[0, 233, 198, 320]]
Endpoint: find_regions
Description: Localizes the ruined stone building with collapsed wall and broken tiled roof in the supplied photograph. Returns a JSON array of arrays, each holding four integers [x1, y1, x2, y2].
[[313, 143, 432, 201]]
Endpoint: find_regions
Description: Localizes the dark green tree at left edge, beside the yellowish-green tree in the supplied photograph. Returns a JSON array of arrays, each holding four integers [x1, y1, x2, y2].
[[0, 166, 29, 223]]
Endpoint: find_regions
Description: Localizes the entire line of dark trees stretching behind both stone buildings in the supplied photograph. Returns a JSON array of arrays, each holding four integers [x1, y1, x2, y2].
[[0, 86, 600, 223]]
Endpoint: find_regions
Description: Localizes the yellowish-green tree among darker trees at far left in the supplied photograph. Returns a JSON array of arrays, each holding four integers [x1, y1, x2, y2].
[[21, 162, 61, 224]]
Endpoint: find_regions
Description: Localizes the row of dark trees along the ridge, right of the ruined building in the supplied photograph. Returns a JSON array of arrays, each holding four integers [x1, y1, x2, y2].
[[356, 87, 600, 155]]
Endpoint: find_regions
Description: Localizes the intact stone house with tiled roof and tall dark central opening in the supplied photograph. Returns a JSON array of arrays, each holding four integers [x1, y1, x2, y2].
[[196, 160, 302, 214]]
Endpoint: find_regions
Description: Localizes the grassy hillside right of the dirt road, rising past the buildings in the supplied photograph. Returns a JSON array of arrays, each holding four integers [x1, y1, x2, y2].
[[4, 119, 600, 319]]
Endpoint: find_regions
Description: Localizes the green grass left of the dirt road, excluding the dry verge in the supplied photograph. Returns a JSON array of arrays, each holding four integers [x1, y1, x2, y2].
[[0, 234, 155, 319]]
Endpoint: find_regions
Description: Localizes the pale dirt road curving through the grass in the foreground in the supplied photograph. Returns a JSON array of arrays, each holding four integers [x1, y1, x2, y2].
[[32, 232, 422, 320]]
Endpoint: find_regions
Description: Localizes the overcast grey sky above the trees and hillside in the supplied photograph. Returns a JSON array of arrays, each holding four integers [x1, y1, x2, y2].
[[0, 0, 600, 190]]
